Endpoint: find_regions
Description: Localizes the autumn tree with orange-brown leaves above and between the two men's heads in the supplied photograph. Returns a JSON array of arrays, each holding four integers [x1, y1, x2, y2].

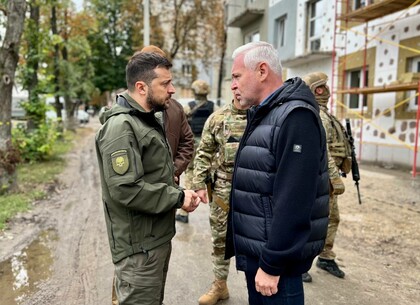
[[156, 0, 226, 97]]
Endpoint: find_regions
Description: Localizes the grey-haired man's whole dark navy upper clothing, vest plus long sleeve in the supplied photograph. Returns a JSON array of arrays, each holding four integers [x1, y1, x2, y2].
[[226, 78, 329, 275]]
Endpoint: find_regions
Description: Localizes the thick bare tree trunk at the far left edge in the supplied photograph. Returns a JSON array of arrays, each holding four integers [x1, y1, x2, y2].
[[0, 0, 26, 191]]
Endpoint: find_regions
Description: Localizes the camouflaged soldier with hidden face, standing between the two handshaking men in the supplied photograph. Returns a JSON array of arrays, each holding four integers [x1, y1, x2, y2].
[[192, 99, 246, 305]]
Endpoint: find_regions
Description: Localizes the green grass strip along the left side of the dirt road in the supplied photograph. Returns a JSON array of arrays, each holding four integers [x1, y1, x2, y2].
[[0, 132, 77, 230]]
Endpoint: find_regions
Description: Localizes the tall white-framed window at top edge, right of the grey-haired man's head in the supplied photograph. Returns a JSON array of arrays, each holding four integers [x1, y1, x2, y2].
[[308, 0, 322, 51]]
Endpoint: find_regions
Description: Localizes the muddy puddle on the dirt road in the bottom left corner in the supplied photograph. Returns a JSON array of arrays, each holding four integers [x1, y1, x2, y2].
[[0, 230, 58, 305]]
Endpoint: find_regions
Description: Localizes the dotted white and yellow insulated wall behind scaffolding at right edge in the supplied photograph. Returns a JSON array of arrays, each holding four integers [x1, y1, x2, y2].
[[338, 6, 420, 166]]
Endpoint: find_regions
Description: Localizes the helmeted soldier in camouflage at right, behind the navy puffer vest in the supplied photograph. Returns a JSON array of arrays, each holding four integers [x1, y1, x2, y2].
[[302, 72, 347, 282]]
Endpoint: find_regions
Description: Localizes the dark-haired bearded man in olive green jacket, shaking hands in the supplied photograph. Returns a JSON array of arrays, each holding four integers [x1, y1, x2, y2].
[[95, 53, 200, 305]]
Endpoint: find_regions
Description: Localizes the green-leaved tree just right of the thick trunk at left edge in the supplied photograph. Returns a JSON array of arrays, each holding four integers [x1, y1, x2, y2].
[[20, 0, 95, 129]]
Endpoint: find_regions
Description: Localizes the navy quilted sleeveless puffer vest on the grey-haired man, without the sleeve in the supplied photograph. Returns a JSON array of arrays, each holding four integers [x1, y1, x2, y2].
[[226, 79, 329, 274]]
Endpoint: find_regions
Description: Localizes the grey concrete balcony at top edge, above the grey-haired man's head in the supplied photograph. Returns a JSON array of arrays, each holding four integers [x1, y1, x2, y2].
[[227, 0, 267, 28]]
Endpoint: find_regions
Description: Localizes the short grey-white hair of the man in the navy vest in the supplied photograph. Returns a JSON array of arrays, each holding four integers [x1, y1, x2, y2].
[[232, 41, 283, 77]]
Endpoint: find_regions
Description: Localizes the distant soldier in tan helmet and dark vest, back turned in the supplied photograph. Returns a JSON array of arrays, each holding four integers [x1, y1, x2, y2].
[[175, 79, 215, 223]]
